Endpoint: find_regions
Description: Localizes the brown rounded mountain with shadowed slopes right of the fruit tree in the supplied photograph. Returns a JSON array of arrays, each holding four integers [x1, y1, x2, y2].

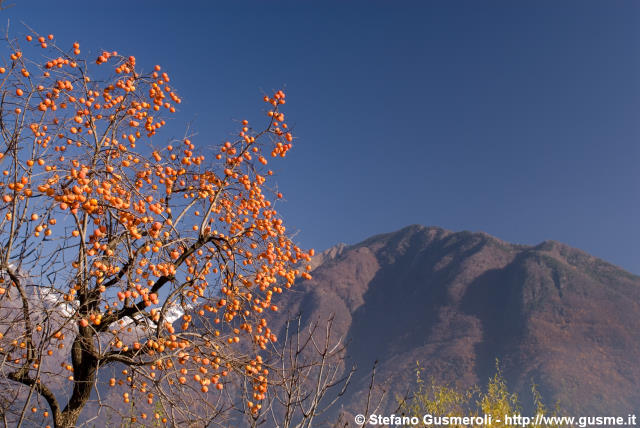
[[271, 225, 640, 415]]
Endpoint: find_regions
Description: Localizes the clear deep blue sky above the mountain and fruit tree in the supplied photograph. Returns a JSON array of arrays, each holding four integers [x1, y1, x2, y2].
[[7, 0, 640, 274]]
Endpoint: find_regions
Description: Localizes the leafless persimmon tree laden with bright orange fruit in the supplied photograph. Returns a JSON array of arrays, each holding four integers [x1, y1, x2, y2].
[[0, 30, 313, 427]]
